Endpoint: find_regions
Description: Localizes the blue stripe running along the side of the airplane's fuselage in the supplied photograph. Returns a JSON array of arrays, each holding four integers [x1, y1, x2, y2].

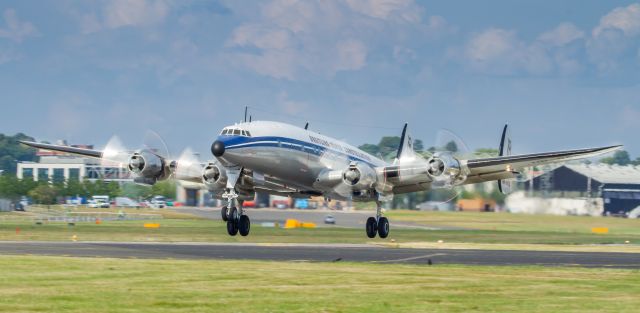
[[218, 136, 377, 167]]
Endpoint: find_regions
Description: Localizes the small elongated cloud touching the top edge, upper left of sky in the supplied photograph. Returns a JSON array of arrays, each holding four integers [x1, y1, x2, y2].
[[79, 0, 170, 34]]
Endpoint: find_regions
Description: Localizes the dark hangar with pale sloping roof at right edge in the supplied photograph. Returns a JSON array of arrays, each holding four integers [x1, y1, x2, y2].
[[523, 164, 640, 215]]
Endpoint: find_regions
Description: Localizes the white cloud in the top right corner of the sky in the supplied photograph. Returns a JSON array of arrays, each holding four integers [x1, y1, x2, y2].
[[593, 3, 640, 37]]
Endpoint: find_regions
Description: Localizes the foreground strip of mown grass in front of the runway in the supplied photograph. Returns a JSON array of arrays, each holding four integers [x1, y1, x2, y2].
[[0, 256, 640, 313]]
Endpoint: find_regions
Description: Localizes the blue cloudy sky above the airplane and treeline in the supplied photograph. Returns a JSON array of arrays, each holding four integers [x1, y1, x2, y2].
[[0, 0, 640, 158]]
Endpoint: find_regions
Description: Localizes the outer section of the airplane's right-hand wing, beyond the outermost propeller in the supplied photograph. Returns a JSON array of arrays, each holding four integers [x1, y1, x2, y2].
[[465, 145, 622, 184]]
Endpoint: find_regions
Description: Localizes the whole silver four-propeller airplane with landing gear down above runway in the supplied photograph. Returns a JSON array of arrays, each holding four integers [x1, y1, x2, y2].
[[21, 120, 622, 238]]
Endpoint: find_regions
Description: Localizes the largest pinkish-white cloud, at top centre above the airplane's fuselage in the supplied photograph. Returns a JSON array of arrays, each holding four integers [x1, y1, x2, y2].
[[226, 0, 446, 80]]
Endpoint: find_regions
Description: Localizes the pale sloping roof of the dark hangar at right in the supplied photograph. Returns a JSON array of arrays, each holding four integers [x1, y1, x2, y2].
[[565, 164, 640, 184]]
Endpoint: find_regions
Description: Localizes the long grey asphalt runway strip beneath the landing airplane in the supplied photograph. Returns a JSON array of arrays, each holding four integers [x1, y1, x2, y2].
[[0, 242, 640, 269]]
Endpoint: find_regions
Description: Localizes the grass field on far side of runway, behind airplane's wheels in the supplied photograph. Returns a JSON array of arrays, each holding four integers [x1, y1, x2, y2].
[[0, 209, 640, 252]]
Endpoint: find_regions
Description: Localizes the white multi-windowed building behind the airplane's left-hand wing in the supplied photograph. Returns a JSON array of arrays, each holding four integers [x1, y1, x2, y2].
[[16, 141, 132, 183]]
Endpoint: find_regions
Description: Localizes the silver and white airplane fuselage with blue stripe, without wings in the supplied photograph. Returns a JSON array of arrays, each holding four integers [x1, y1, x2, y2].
[[217, 121, 387, 195]]
